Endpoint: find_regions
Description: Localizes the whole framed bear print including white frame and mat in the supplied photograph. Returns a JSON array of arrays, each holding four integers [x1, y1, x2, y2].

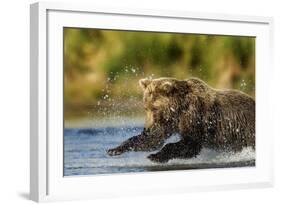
[[30, 3, 273, 201]]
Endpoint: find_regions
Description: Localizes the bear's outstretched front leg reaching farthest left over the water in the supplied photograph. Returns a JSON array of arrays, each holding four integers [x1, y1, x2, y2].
[[107, 129, 169, 156]]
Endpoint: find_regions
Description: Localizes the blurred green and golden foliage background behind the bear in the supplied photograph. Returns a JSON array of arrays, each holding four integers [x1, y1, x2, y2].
[[64, 28, 255, 119]]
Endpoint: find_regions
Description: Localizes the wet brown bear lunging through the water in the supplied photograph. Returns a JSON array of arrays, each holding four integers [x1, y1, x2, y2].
[[108, 78, 255, 162]]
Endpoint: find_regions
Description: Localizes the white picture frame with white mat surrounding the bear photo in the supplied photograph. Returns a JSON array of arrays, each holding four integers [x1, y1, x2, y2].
[[30, 2, 273, 202]]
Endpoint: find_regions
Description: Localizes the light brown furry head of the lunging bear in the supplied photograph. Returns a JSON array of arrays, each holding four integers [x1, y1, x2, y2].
[[139, 78, 188, 131]]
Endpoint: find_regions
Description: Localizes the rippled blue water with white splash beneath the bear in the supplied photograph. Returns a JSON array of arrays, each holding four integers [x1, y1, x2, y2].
[[64, 126, 255, 176]]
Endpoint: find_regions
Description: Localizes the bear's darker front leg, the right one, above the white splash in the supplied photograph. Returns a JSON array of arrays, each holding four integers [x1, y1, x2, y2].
[[148, 139, 202, 163]]
